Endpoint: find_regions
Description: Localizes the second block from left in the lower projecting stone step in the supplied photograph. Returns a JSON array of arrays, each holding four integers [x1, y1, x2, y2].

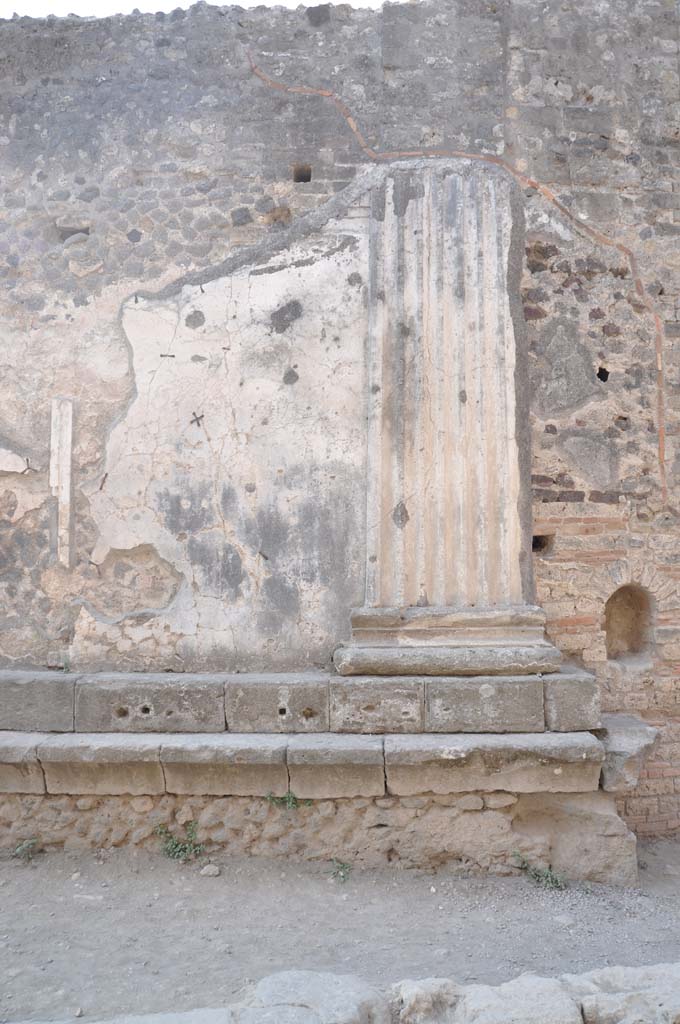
[[37, 733, 165, 797]]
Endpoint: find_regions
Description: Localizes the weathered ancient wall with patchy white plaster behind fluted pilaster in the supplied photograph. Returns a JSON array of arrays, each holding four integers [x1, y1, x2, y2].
[[0, 0, 680, 833]]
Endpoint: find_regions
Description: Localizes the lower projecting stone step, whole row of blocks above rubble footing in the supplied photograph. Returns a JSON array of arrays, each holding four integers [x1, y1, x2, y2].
[[0, 732, 605, 800]]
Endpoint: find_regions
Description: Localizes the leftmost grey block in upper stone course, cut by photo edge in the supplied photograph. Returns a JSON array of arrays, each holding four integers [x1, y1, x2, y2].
[[0, 670, 78, 732]]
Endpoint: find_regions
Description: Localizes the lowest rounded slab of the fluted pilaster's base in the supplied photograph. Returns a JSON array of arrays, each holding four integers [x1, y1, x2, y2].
[[333, 643, 561, 676]]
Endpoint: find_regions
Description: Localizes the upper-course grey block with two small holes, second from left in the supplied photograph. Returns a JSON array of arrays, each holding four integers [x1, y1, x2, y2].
[[76, 673, 226, 732]]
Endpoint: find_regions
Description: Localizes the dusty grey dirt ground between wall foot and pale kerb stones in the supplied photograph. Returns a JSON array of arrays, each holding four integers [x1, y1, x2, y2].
[[0, 837, 680, 1022]]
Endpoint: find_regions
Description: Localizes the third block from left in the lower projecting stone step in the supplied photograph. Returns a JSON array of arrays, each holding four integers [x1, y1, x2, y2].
[[161, 733, 288, 797]]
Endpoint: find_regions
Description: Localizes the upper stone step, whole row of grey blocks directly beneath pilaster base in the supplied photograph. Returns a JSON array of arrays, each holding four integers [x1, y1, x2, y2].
[[0, 668, 600, 734]]
